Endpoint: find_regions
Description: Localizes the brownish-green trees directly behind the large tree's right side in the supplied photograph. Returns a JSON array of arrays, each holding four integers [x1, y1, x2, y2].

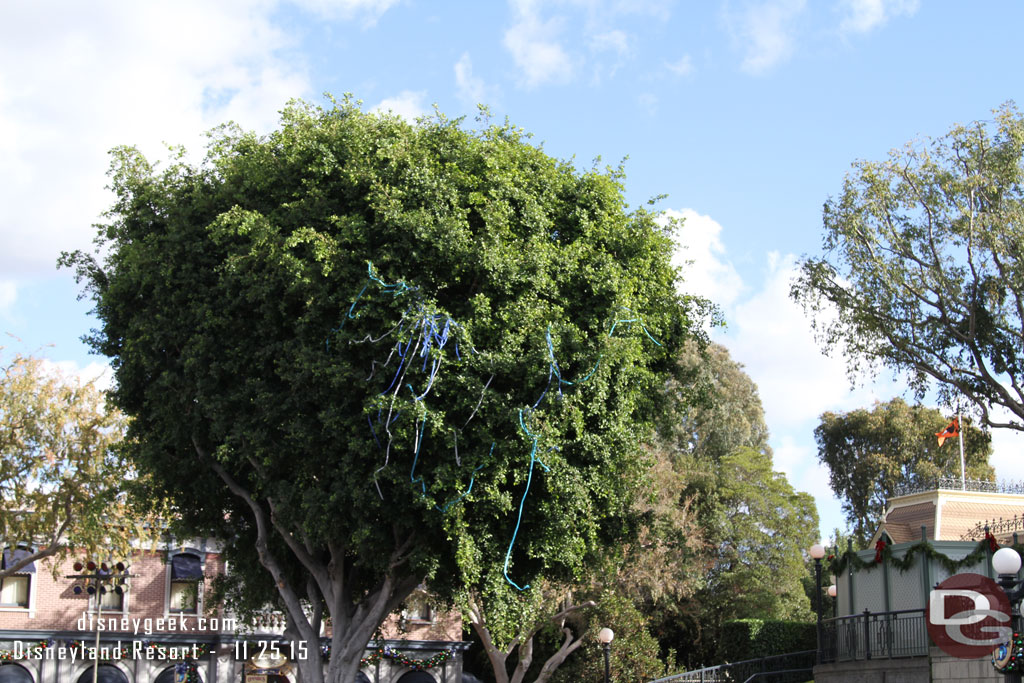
[[647, 344, 818, 668]]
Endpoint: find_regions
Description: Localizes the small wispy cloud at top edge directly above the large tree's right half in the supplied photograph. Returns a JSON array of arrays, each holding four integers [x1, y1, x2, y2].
[[504, 0, 575, 88]]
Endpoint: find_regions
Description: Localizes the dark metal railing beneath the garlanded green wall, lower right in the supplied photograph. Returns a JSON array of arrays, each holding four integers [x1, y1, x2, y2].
[[819, 609, 929, 664]]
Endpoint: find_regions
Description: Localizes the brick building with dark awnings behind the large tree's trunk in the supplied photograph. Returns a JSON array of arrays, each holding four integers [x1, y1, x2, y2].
[[0, 542, 468, 683]]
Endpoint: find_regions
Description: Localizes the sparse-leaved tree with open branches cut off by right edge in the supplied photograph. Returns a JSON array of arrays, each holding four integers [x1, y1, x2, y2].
[[792, 103, 1024, 430]]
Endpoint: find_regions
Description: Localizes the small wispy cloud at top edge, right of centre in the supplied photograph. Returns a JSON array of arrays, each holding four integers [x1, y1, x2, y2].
[[726, 0, 806, 75]]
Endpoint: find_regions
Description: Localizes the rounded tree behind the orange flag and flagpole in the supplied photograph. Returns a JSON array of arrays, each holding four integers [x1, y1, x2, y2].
[[814, 398, 995, 550]]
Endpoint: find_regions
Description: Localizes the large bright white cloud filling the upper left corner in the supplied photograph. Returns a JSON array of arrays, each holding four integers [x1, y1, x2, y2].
[[0, 0, 310, 278]]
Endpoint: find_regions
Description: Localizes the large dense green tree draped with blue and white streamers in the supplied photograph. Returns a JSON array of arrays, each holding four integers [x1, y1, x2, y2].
[[65, 100, 700, 683]]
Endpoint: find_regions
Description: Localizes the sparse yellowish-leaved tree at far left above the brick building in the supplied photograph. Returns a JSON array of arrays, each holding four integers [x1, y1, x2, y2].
[[0, 355, 144, 577]]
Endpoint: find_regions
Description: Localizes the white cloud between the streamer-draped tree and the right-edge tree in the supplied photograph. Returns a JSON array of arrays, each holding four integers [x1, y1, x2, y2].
[[668, 209, 900, 530]]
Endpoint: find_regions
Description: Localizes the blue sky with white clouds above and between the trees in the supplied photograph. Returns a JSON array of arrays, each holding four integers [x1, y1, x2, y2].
[[6, 0, 1024, 535]]
